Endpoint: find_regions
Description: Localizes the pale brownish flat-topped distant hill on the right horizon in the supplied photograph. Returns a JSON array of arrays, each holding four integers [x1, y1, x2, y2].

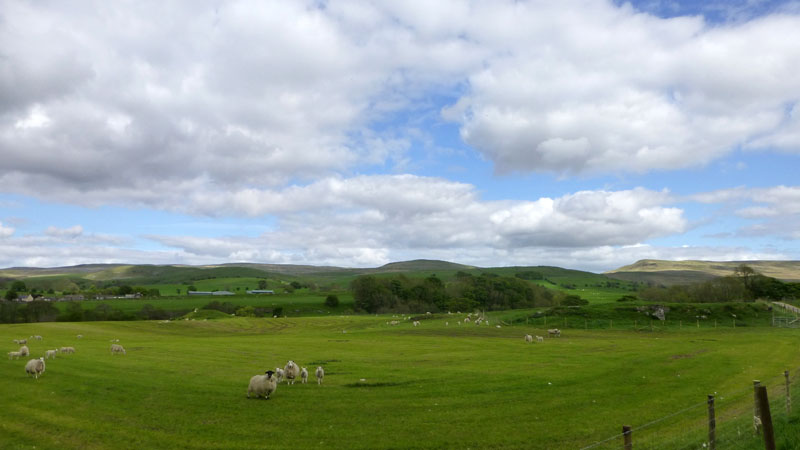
[[605, 259, 800, 286]]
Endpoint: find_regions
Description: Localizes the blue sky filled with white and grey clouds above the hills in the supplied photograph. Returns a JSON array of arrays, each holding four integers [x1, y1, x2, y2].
[[0, 0, 800, 272]]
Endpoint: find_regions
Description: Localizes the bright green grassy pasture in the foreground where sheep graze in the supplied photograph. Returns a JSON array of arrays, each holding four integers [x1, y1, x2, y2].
[[0, 314, 800, 449]]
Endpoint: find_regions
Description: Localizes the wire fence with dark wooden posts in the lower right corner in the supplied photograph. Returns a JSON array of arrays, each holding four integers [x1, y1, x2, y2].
[[581, 369, 800, 450]]
